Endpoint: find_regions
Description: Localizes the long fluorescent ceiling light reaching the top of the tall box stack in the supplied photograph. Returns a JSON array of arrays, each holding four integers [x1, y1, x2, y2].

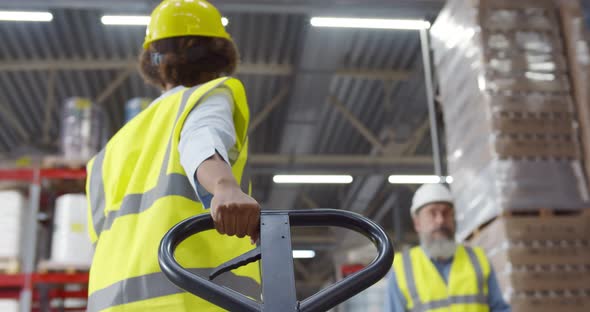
[[311, 17, 430, 30]]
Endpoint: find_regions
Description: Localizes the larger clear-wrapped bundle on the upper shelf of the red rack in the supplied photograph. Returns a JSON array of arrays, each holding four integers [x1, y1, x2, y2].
[[61, 98, 108, 160]]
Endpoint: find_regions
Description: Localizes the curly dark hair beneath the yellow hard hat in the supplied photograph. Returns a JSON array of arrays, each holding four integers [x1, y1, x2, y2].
[[139, 36, 239, 89]]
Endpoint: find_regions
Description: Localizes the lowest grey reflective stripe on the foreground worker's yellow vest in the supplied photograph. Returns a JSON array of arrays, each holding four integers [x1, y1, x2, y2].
[[87, 269, 260, 312]]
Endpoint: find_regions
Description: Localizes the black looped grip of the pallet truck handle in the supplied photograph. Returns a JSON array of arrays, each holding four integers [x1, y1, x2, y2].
[[158, 209, 394, 312]]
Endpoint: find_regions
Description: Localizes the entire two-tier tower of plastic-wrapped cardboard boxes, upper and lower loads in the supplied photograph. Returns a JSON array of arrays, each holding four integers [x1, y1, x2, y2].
[[431, 0, 590, 312]]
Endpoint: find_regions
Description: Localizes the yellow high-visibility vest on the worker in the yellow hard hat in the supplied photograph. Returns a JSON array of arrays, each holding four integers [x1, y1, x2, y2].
[[86, 78, 260, 312]]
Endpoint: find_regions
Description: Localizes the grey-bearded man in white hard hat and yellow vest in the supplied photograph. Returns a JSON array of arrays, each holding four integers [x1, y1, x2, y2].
[[384, 184, 511, 312]]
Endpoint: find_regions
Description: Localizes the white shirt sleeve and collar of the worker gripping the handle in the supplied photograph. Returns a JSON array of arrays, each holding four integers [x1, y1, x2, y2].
[[154, 86, 237, 208]]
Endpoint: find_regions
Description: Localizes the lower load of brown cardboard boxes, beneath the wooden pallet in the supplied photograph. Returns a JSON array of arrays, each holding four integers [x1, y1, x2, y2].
[[470, 213, 590, 312]]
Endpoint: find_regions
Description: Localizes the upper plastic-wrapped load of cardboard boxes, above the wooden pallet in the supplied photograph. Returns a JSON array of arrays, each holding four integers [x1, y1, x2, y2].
[[431, 0, 588, 238]]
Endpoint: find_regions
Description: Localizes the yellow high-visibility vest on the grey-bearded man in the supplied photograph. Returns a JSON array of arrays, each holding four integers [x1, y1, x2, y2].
[[393, 246, 491, 312]]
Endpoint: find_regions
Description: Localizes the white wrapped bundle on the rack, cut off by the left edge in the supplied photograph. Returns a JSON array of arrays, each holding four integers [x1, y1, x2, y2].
[[0, 191, 27, 258]]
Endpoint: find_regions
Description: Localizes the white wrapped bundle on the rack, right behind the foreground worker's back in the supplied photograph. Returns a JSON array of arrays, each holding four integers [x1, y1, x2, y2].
[[51, 194, 93, 266]]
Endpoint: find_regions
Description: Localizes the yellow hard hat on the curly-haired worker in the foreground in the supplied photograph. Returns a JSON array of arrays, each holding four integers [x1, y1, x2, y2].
[[143, 0, 231, 50]]
